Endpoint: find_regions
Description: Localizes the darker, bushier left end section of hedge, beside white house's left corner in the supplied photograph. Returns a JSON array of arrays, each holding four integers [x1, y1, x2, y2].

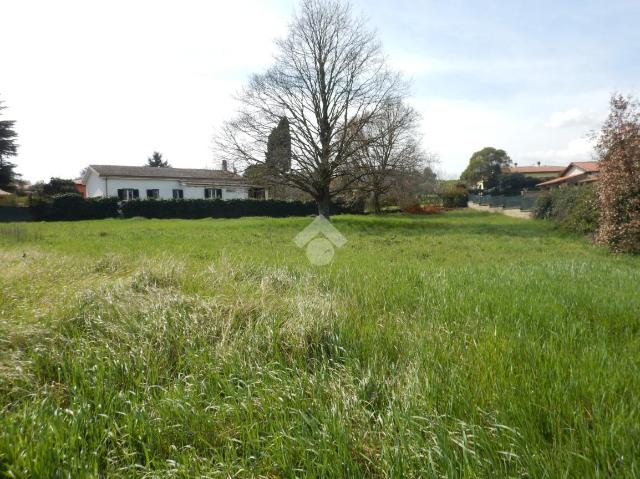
[[31, 193, 119, 221]]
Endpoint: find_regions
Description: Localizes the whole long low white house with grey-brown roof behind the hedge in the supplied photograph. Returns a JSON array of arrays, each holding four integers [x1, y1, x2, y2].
[[82, 165, 265, 200]]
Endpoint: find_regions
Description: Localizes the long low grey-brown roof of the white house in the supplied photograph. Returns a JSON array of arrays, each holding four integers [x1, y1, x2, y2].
[[89, 165, 245, 182]]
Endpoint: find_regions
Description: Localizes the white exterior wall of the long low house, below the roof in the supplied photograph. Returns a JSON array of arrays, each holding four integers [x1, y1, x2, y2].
[[87, 172, 249, 200]]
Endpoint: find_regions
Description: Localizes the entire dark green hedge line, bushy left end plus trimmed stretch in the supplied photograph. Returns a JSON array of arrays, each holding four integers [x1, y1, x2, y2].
[[30, 193, 364, 221]]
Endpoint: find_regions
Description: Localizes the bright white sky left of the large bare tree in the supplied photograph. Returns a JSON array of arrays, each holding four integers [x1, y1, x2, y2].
[[0, 0, 291, 181]]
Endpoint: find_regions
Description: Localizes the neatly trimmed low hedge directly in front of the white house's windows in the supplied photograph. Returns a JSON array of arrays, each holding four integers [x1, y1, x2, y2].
[[121, 200, 362, 219]]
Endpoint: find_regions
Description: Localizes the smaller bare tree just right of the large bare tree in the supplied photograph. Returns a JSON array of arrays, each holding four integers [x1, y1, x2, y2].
[[358, 100, 428, 213]]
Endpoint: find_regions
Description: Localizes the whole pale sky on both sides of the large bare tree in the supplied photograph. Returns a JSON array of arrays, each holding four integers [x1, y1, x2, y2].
[[0, 0, 640, 181]]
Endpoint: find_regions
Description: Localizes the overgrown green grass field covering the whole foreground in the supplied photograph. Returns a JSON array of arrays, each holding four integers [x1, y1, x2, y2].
[[0, 211, 640, 478]]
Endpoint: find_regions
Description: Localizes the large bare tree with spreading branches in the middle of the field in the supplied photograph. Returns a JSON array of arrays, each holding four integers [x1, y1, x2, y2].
[[216, 0, 404, 217]]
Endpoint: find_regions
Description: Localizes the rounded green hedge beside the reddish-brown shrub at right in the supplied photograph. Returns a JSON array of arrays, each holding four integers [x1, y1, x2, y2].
[[533, 185, 600, 234]]
